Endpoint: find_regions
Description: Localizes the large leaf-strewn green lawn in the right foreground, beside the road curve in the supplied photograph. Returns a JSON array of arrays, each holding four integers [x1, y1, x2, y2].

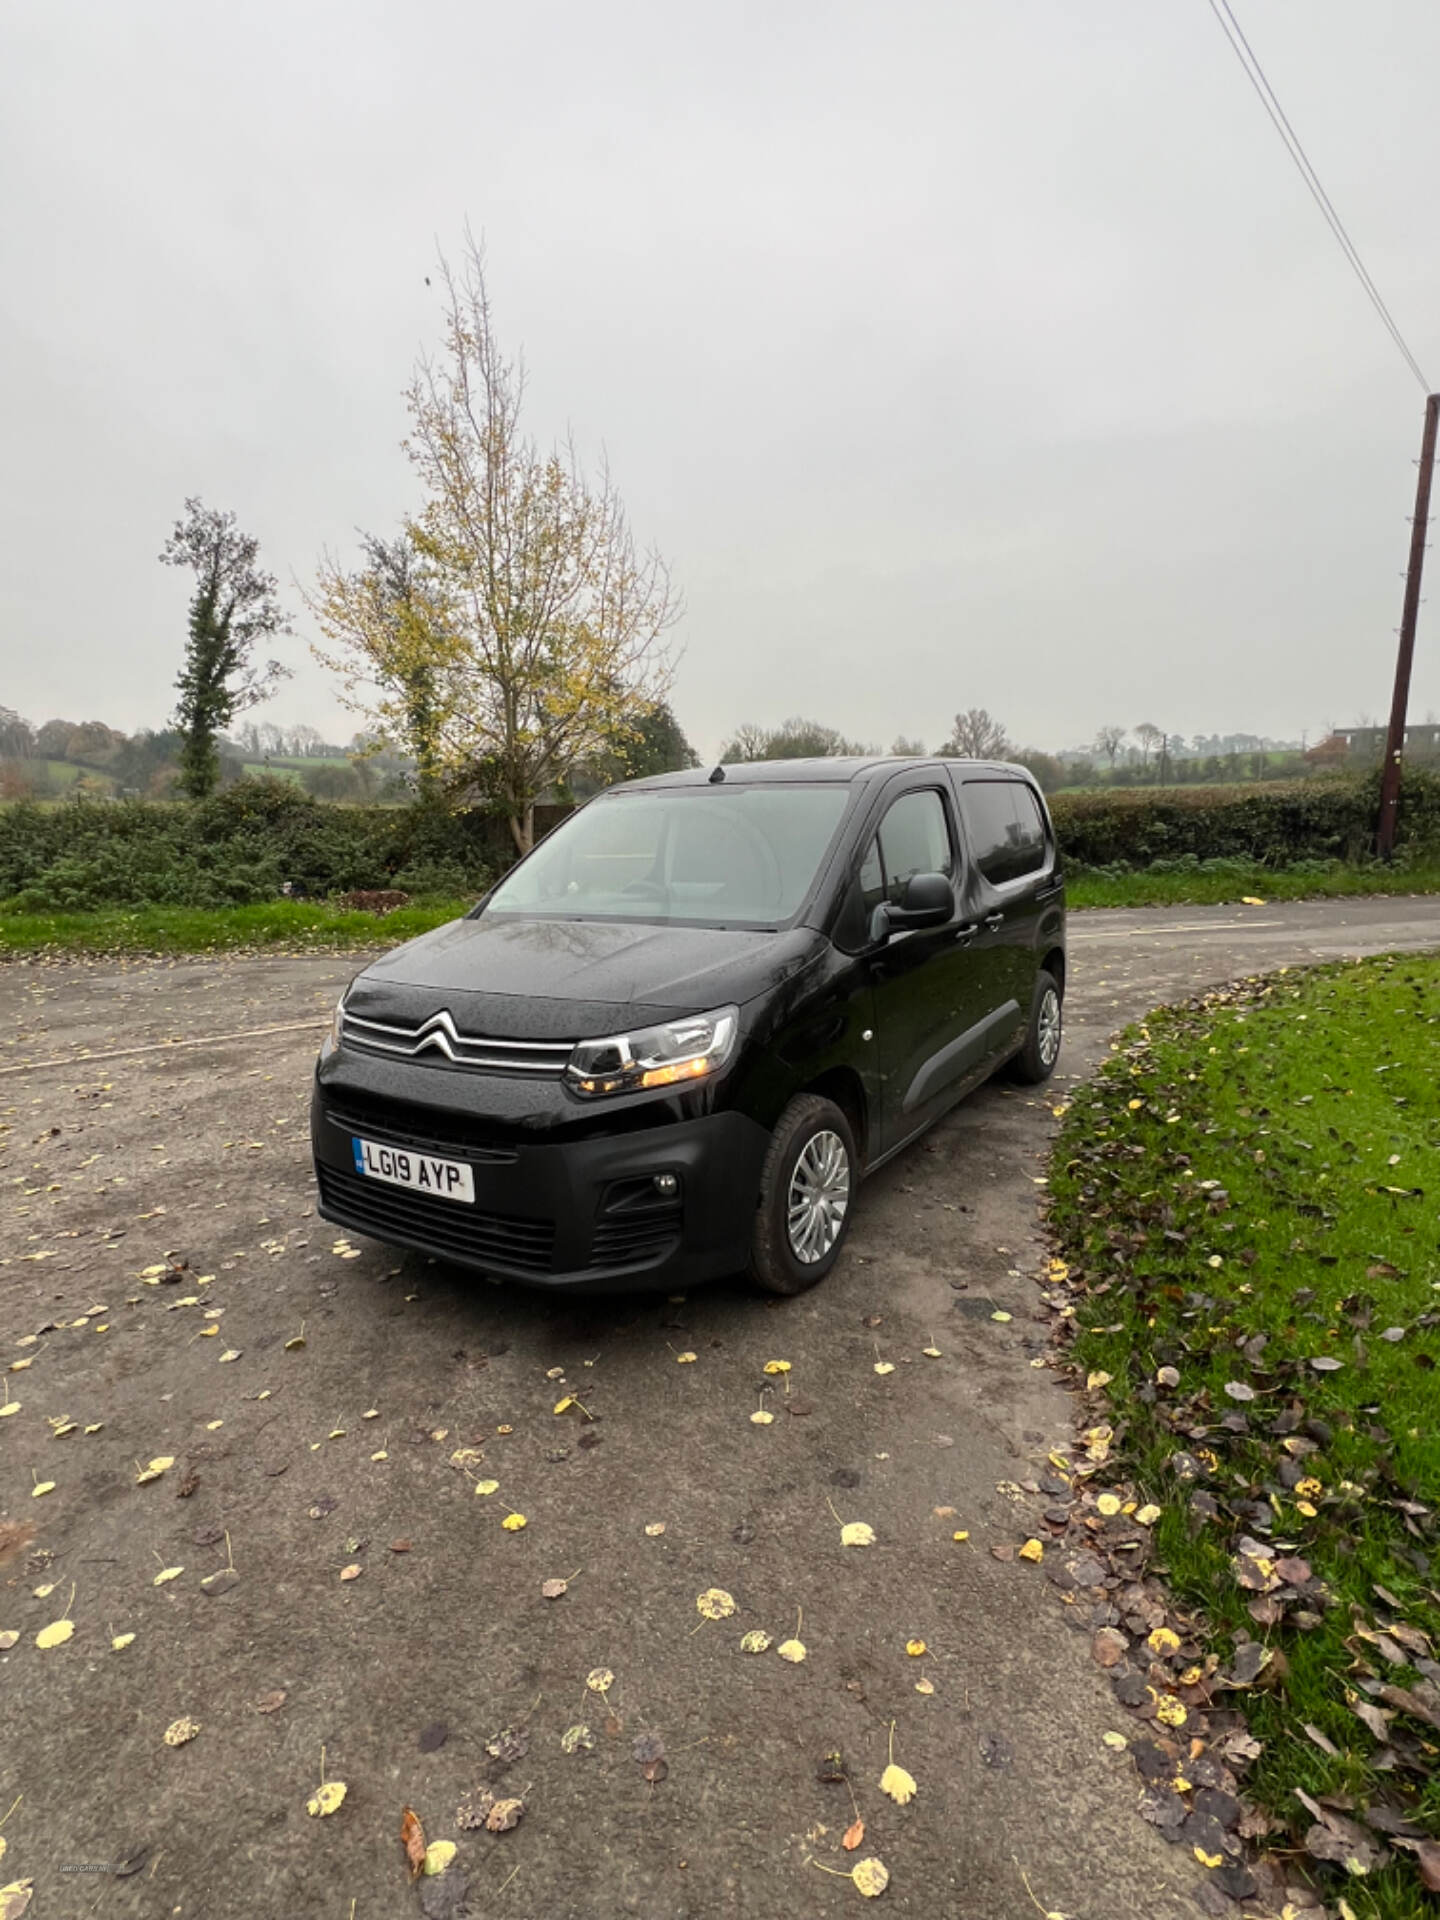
[[1050, 956, 1440, 1920]]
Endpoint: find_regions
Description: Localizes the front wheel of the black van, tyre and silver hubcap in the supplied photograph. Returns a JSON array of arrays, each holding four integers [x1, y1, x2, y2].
[[751, 1092, 860, 1294]]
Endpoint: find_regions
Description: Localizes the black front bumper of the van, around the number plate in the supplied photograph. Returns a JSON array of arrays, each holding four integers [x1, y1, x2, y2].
[[311, 1064, 770, 1292]]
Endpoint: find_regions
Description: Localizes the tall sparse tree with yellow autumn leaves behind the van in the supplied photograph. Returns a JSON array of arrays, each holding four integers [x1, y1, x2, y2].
[[309, 242, 680, 852]]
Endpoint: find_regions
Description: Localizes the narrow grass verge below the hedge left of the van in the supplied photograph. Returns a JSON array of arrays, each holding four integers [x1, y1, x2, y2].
[[0, 899, 474, 958]]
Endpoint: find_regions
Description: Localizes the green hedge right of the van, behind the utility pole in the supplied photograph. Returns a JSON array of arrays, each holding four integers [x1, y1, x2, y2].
[[1050, 772, 1440, 866]]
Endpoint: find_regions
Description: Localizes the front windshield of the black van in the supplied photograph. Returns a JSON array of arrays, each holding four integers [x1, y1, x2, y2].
[[486, 781, 851, 927]]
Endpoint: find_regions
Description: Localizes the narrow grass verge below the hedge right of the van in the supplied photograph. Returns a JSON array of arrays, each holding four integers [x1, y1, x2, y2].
[[1066, 860, 1440, 906]]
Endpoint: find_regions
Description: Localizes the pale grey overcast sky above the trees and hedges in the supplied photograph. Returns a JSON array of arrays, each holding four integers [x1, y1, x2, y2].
[[0, 0, 1440, 753]]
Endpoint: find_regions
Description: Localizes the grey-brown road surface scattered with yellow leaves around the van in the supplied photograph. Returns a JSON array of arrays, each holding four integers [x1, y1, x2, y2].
[[0, 899, 1440, 1920]]
